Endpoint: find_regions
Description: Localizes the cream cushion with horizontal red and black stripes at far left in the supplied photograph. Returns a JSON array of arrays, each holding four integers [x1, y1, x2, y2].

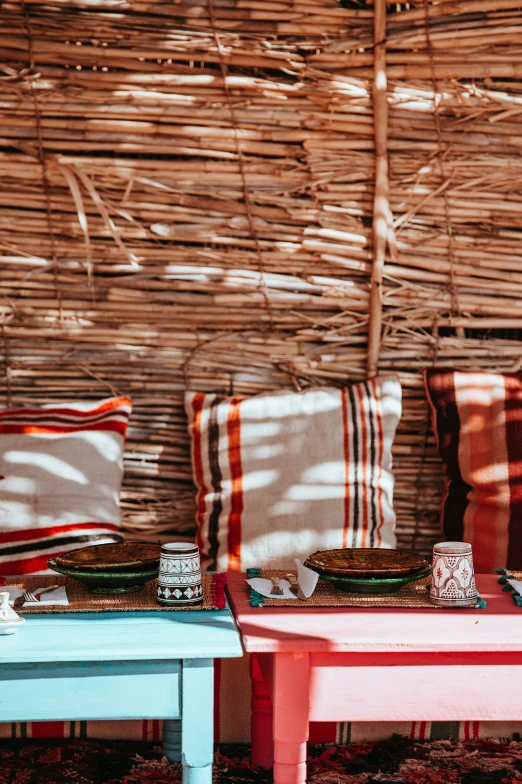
[[0, 397, 131, 575]]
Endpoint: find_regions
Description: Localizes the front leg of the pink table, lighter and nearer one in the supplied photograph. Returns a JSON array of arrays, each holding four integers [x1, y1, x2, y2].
[[272, 653, 310, 784]]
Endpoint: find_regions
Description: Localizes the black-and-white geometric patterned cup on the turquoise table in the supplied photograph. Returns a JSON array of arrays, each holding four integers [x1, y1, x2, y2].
[[157, 542, 203, 607]]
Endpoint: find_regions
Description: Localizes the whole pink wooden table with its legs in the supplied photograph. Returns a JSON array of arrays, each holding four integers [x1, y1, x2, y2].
[[228, 574, 522, 784]]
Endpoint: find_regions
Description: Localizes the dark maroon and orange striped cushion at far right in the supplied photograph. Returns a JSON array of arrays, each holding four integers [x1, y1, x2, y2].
[[425, 368, 522, 572]]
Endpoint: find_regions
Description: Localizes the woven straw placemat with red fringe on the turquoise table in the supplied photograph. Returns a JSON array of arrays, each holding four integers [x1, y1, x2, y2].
[[6, 574, 225, 615]]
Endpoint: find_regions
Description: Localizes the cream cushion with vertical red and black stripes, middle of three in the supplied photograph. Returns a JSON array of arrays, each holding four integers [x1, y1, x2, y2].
[[185, 376, 401, 571]]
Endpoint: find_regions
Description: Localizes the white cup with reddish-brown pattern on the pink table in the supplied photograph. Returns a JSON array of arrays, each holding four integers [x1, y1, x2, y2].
[[430, 542, 478, 607]]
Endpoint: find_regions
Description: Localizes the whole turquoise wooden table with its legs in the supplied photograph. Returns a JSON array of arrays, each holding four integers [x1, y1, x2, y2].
[[0, 608, 242, 784]]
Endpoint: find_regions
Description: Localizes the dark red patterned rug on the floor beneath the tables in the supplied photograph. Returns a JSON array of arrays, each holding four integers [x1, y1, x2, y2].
[[0, 738, 522, 784]]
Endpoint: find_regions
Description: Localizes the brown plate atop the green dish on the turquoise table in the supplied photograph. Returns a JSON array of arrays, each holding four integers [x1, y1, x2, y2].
[[55, 542, 160, 572]]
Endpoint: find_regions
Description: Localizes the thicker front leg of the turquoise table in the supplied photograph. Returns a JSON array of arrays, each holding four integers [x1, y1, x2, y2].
[[181, 659, 214, 784]]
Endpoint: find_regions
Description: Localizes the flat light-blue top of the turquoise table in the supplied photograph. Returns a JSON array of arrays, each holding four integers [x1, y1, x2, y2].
[[0, 608, 242, 665]]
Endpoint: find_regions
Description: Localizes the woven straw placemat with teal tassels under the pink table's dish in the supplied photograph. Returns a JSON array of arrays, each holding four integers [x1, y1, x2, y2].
[[247, 569, 485, 610]]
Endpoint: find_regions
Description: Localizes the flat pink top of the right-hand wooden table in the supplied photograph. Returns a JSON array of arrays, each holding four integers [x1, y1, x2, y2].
[[227, 573, 522, 653]]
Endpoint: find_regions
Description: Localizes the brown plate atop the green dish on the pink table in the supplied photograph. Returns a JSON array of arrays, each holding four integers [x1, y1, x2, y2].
[[305, 547, 429, 578]]
